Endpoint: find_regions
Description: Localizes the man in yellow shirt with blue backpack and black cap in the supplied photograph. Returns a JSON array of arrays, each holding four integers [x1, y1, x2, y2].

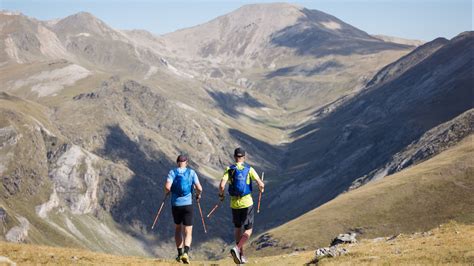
[[219, 148, 265, 264]]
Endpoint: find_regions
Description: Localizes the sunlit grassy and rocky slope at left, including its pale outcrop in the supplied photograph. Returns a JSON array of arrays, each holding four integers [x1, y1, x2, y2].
[[0, 93, 148, 255]]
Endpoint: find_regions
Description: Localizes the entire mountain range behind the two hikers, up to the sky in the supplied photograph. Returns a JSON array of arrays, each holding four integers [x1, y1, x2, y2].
[[0, 3, 474, 258]]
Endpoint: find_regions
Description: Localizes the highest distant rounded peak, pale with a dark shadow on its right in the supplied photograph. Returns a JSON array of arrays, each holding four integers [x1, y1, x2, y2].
[[163, 3, 410, 64]]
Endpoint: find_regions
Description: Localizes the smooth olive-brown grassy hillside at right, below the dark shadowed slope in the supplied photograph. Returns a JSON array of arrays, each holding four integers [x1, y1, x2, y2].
[[255, 135, 474, 256]]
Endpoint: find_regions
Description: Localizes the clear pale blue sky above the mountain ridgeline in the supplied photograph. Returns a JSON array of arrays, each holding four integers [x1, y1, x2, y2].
[[0, 0, 473, 41]]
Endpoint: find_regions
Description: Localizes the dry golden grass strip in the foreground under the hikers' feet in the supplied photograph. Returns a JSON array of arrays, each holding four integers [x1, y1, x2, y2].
[[0, 222, 474, 265]]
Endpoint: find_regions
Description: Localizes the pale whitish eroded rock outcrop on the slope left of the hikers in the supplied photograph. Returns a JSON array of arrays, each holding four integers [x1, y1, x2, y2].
[[36, 139, 133, 218]]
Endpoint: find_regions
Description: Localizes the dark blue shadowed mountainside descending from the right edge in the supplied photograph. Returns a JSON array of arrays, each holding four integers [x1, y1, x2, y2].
[[262, 32, 474, 228]]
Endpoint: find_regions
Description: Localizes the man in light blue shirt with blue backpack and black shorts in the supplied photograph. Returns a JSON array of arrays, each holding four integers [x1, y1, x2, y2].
[[165, 155, 202, 264]]
